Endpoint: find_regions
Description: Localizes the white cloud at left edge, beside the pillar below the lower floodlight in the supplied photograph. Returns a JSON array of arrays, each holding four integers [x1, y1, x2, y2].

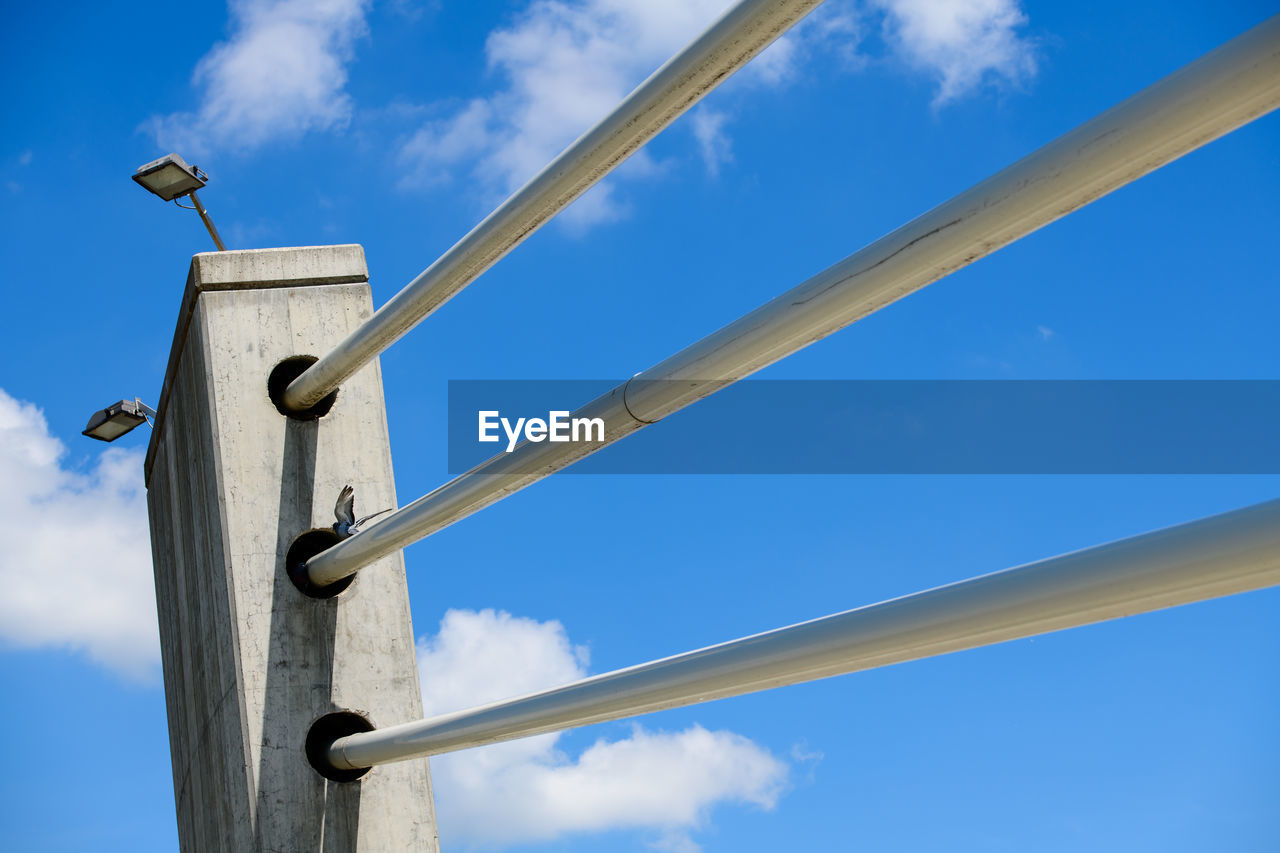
[[0, 391, 160, 678]]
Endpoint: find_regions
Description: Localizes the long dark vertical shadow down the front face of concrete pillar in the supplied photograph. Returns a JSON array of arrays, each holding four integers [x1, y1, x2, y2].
[[255, 419, 361, 853]]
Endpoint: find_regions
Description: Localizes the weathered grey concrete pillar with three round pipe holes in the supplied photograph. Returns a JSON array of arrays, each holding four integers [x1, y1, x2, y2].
[[146, 246, 438, 853]]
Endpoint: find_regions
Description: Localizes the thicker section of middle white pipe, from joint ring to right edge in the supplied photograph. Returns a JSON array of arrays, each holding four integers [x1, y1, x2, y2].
[[626, 15, 1280, 421]]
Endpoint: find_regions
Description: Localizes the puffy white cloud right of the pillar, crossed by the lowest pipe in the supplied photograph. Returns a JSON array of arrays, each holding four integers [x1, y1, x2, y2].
[[419, 610, 788, 853]]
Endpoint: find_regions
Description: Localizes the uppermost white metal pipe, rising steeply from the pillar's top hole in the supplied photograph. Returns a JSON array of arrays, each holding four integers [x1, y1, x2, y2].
[[284, 0, 822, 411]]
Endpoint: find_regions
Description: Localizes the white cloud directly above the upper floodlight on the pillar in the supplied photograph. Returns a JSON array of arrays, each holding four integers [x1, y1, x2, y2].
[[150, 0, 369, 155]]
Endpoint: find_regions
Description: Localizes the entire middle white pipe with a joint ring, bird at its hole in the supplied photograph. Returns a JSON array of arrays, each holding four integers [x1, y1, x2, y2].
[[307, 15, 1280, 585]]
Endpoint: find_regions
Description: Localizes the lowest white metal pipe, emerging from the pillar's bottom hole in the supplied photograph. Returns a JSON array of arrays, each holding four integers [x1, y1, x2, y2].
[[329, 501, 1280, 770]]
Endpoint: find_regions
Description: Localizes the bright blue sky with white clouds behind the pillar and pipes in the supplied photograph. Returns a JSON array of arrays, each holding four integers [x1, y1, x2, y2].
[[0, 0, 1280, 852]]
